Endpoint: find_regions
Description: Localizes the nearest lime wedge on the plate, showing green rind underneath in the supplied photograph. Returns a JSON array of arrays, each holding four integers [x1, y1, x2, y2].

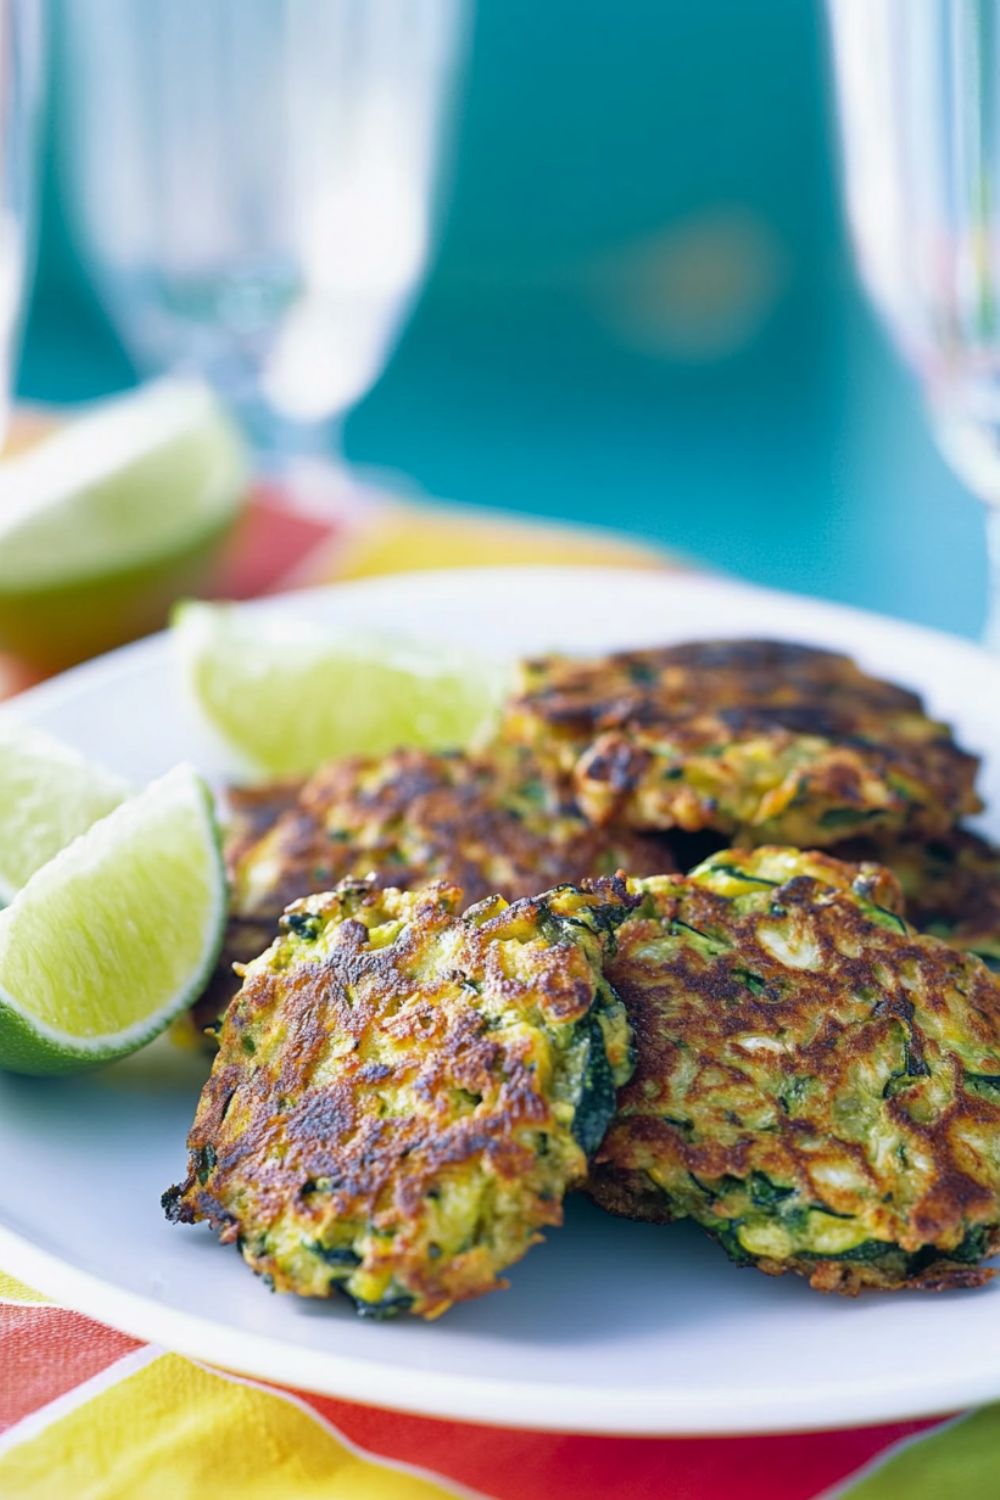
[[0, 767, 226, 1074]]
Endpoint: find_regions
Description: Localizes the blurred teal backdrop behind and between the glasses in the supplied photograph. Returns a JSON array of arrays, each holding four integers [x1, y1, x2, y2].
[[13, 0, 985, 635]]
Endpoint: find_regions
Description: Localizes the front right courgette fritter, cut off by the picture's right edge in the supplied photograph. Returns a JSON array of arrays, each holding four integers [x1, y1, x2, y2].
[[589, 849, 1000, 1293]]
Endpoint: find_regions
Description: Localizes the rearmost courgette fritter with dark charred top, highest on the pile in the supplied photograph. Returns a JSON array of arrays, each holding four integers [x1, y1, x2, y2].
[[502, 641, 981, 848]]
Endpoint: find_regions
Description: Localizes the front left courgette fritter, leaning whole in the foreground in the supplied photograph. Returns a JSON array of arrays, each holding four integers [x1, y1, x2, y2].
[[163, 879, 631, 1317]]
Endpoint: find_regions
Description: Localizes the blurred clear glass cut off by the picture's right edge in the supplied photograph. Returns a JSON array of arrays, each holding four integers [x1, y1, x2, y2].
[[828, 0, 1000, 650]]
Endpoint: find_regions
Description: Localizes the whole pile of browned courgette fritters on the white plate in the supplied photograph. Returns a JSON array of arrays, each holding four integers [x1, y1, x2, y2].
[[166, 641, 1000, 1316]]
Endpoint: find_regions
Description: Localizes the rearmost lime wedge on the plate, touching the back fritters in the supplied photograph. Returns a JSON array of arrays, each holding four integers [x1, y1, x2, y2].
[[174, 603, 507, 776]]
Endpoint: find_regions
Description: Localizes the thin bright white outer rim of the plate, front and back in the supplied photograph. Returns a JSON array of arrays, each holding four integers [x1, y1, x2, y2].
[[0, 564, 1000, 1437]]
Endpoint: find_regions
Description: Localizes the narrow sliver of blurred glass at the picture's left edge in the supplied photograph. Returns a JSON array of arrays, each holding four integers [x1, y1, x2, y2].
[[0, 0, 42, 443]]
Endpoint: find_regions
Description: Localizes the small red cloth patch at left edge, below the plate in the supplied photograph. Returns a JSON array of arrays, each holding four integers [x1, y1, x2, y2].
[[0, 1302, 141, 1433]]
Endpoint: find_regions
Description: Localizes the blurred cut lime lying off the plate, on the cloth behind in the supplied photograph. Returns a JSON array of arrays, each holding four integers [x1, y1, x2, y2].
[[0, 380, 249, 671]]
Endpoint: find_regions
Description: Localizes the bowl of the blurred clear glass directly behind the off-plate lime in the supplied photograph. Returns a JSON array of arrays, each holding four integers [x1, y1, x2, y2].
[[58, 0, 469, 492]]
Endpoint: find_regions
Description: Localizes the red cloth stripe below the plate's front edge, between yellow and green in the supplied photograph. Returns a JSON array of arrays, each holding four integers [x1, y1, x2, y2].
[[287, 1392, 937, 1500]]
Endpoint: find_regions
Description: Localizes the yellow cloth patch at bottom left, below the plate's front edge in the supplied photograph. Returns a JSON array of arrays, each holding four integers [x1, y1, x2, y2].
[[0, 1355, 456, 1500]]
